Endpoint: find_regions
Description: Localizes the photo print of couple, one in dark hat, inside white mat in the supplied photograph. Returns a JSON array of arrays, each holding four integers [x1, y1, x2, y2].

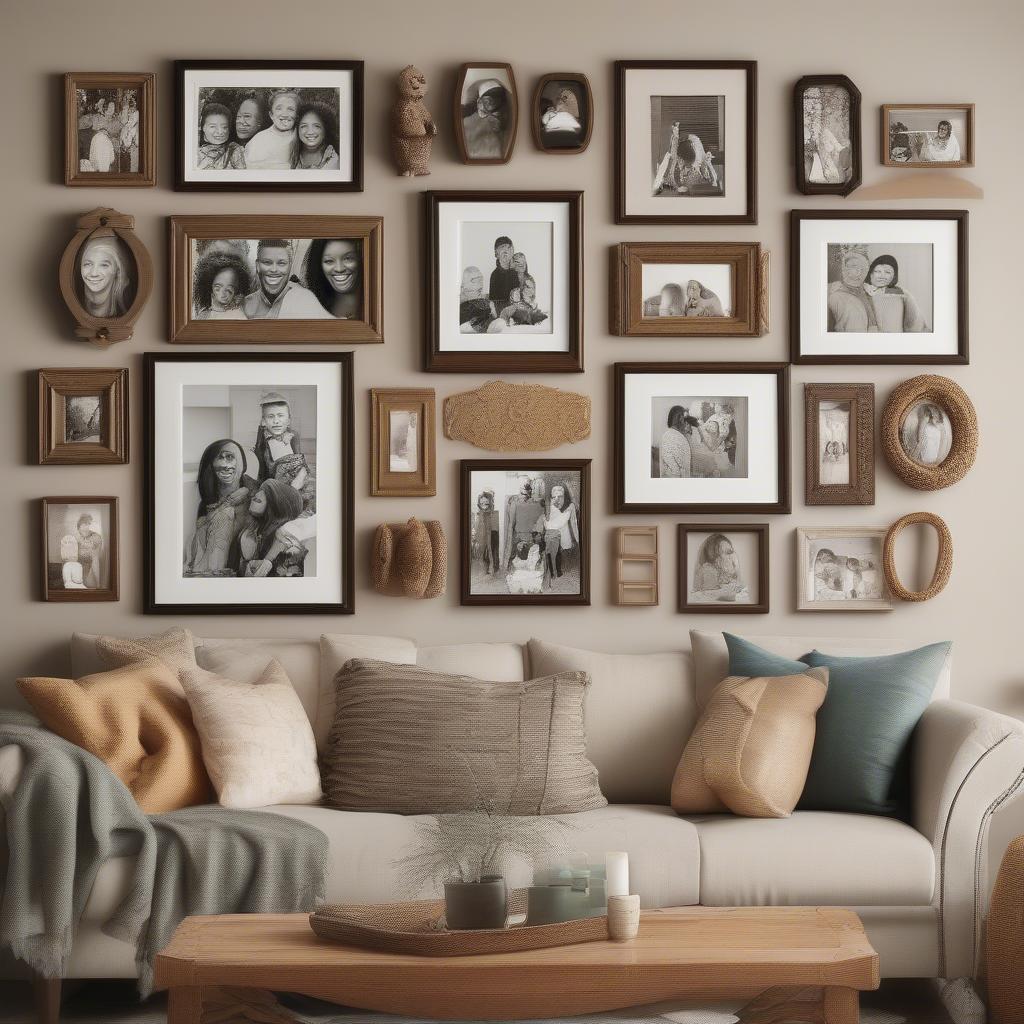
[[826, 242, 934, 334]]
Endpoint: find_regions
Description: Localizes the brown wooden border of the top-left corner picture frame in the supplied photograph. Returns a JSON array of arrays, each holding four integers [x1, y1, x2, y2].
[[65, 71, 157, 188]]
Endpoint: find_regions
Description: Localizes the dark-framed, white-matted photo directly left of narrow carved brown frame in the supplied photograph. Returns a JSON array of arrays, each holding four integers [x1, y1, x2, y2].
[[614, 362, 790, 515]]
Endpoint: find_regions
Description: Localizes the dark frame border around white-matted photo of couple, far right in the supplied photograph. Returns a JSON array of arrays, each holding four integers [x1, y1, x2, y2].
[[790, 210, 971, 366]]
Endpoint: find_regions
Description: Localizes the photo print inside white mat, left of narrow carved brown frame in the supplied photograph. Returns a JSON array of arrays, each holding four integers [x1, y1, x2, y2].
[[650, 395, 749, 479]]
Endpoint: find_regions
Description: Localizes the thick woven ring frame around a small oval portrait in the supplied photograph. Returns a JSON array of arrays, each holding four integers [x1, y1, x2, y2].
[[882, 374, 978, 490]]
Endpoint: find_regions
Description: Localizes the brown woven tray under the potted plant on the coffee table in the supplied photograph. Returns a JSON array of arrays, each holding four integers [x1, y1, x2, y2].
[[309, 893, 608, 956]]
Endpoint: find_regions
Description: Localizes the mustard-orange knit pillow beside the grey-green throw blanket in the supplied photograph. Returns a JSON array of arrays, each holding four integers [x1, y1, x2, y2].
[[17, 658, 214, 814]]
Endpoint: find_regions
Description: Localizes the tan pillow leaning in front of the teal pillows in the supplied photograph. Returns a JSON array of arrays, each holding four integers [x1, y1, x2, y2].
[[672, 669, 828, 818]]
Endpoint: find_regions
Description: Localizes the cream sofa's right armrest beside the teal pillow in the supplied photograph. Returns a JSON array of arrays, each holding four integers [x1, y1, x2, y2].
[[913, 700, 1024, 978]]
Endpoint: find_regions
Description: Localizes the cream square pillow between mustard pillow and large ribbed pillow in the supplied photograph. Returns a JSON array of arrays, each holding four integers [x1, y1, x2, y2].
[[179, 659, 321, 807]]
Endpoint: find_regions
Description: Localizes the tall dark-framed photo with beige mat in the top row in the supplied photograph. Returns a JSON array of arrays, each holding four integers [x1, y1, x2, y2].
[[615, 60, 758, 224]]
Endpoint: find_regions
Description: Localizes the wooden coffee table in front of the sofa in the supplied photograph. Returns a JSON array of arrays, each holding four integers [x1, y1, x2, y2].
[[156, 907, 879, 1024]]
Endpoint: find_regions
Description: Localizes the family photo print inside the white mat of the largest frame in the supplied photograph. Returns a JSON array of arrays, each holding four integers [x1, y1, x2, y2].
[[181, 383, 316, 579]]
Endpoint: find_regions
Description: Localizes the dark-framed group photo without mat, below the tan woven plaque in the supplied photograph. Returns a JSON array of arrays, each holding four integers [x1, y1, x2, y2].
[[459, 459, 590, 605]]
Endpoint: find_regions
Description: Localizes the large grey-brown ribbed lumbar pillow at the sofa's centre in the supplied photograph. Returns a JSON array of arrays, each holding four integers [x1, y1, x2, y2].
[[322, 658, 607, 815]]
